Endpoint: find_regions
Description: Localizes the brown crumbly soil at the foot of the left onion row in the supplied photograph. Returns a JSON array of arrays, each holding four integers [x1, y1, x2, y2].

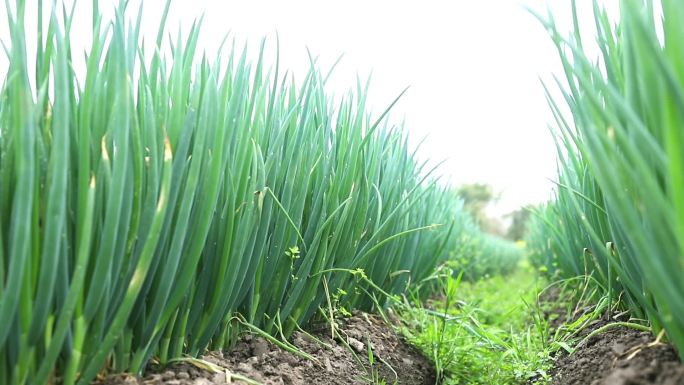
[[94, 313, 435, 385]]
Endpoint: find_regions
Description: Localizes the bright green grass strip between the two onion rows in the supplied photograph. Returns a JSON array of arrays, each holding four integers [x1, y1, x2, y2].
[[400, 261, 552, 385]]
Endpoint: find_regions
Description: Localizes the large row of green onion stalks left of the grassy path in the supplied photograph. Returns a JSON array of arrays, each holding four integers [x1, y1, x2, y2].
[[0, 1, 496, 385]]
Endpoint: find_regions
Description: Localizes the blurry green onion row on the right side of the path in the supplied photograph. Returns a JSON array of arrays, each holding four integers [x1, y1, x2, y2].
[[530, 0, 684, 360]]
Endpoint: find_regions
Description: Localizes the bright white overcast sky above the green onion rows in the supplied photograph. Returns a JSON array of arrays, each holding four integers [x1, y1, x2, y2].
[[0, 0, 618, 213]]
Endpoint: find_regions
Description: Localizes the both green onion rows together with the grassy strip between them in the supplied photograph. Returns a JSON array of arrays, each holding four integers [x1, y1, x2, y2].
[[0, 0, 684, 385]]
